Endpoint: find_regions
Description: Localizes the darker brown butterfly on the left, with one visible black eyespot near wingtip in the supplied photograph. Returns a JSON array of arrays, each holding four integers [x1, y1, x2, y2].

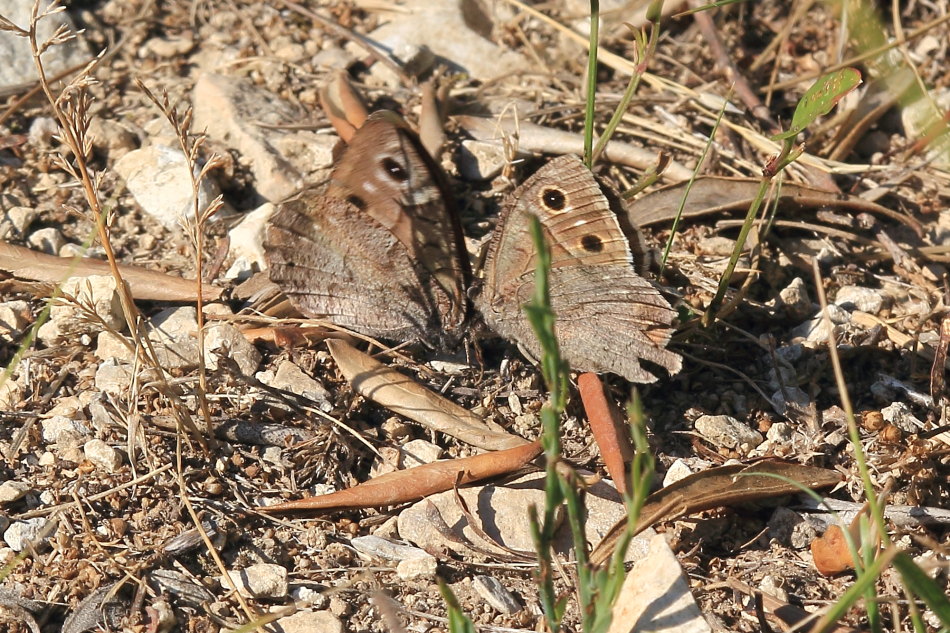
[[264, 113, 471, 345]]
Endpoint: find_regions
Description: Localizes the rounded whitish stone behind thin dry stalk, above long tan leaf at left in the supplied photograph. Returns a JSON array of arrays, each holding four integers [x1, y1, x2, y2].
[[115, 145, 218, 230]]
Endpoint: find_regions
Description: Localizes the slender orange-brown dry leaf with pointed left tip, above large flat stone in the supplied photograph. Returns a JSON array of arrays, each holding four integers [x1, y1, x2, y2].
[[260, 441, 541, 513]]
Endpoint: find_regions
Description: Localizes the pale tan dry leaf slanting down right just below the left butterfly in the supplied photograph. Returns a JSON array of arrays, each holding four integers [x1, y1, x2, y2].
[[327, 339, 528, 451]]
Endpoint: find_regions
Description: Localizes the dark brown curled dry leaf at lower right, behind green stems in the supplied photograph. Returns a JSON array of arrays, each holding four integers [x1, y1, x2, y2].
[[590, 460, 841, 565]]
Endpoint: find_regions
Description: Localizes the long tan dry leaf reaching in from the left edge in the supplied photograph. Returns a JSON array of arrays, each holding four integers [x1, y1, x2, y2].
[[0, 242, 222, 302]]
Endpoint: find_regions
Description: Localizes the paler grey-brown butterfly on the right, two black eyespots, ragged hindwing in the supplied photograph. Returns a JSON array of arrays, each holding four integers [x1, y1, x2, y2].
[[476, 156, 682, 383]]
